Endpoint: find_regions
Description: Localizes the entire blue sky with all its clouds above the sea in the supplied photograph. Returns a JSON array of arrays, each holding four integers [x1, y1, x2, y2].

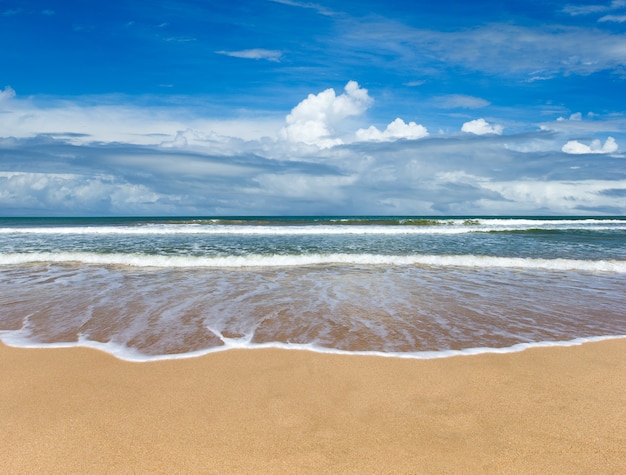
[[0, 0, 626, 216]]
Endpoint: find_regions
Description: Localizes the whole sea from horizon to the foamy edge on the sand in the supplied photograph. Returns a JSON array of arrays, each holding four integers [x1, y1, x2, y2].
[[0, 216, 626, 361]]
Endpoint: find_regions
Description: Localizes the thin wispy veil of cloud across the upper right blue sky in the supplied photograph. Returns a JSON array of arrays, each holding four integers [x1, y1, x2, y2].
[[342, 19, 626, 79]]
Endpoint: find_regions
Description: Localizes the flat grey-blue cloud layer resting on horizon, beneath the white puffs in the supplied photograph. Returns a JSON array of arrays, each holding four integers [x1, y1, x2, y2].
[[0, 126, 626, 215]]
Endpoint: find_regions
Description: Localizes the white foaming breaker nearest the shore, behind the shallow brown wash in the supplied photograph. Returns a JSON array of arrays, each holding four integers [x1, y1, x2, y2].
[[0, 252, 626, 274]]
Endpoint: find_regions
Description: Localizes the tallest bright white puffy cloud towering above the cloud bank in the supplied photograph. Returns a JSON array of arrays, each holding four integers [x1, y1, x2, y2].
[[279, 81, 372, 148]]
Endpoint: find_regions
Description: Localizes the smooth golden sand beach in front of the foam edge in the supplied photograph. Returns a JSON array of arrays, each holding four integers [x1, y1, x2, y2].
[[0, 340, 626, 474]]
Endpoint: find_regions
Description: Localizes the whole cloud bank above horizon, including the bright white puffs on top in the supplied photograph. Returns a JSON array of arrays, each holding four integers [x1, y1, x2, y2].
[[0, 81, 626, 215]]
